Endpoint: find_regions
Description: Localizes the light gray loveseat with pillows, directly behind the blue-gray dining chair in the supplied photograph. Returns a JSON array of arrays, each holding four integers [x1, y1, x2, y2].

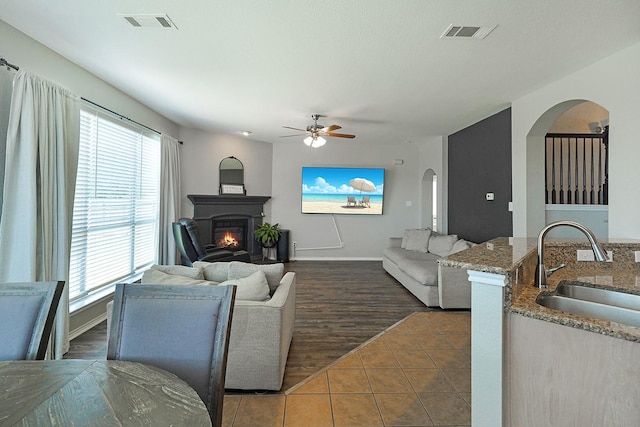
[[107, 261, 296, 390]]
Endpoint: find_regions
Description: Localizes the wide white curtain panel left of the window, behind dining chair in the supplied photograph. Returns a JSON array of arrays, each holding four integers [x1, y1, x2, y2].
[[0, 70, 80, 359]]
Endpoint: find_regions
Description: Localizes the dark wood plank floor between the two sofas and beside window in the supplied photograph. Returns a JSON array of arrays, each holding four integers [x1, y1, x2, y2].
[[65, 261, 444, 392]]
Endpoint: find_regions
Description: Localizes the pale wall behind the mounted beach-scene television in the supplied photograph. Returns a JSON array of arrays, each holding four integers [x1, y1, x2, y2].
[[270, 139, 442, 260]]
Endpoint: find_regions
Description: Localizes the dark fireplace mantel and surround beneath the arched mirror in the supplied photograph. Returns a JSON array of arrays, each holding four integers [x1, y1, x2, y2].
[[187, 194, 271, 259]]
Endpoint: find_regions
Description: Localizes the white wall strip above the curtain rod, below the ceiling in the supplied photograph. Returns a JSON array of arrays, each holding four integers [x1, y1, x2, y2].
[[0, 20, 178, 136]]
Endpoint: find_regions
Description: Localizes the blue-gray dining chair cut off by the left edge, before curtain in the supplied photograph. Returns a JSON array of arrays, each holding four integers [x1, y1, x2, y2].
[[0, 281, 65, 360]]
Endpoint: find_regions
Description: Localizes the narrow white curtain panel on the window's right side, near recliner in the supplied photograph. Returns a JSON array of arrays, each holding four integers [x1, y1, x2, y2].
[[158, 135, 180, 265]]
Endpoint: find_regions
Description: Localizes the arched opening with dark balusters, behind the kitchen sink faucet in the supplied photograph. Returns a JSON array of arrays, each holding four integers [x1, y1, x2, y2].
[[527, 100, 609, 238]]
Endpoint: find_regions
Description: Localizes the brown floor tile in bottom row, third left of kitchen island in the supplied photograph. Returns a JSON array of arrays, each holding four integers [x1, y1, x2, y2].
[[331, 394, 383, 427]]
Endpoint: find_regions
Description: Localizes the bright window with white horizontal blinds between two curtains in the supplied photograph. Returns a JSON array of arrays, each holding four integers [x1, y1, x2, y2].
[[69, 105, 160, 300]]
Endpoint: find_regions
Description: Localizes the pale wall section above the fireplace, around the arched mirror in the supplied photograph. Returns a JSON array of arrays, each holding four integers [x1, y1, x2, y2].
[[180, 127, 272, 218]]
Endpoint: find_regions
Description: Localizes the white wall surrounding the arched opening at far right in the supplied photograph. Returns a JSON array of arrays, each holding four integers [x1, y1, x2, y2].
[[512, 43, 640, 239]]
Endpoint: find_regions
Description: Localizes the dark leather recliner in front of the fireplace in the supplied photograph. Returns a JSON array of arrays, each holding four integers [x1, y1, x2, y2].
[[172, 218, 251, 266]]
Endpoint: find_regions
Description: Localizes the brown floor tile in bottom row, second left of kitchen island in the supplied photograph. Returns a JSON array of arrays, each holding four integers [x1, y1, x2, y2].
[[375, 393, 433, 426]]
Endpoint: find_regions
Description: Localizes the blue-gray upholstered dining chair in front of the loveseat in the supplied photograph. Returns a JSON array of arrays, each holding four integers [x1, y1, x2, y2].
[[107, 284, 236, 426]]
